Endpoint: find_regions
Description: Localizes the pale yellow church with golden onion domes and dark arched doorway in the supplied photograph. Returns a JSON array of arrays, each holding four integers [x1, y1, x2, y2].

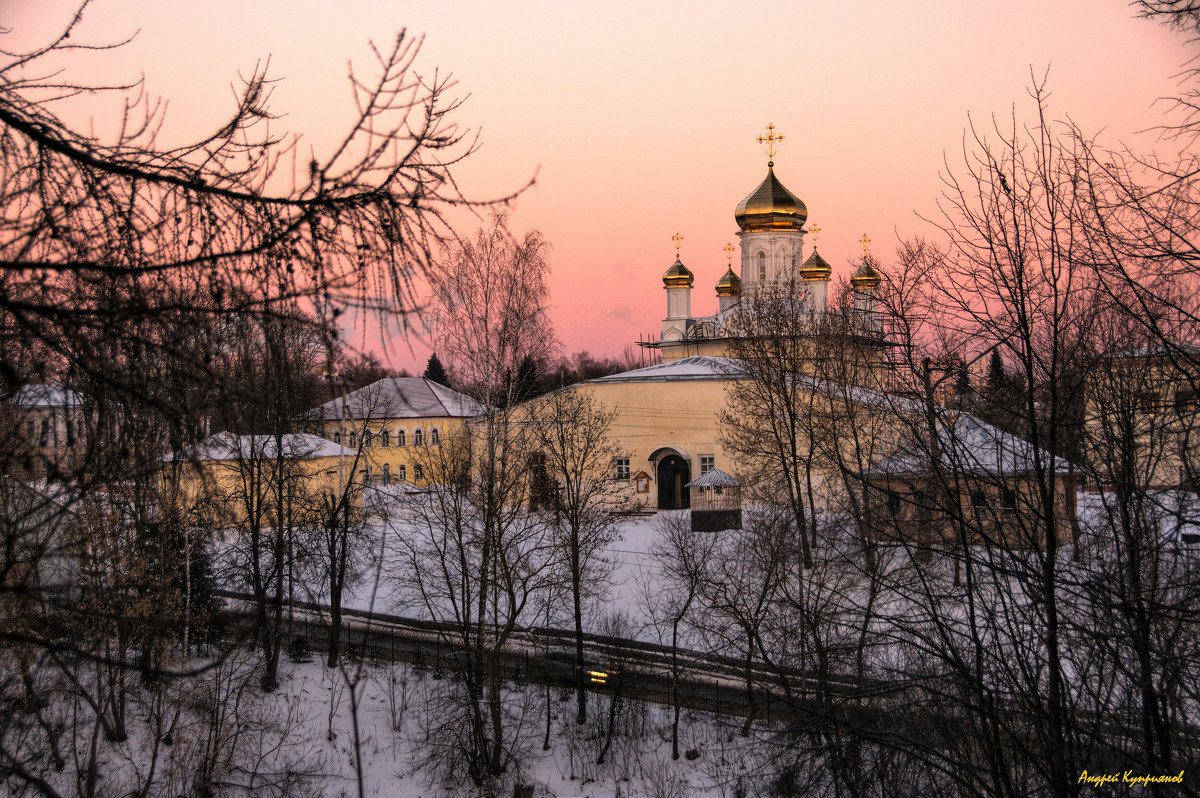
[[576, 127, 886, 509]]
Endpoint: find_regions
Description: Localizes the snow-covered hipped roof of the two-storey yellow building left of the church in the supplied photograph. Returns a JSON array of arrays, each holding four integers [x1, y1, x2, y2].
[[306, 377, 484, 421]]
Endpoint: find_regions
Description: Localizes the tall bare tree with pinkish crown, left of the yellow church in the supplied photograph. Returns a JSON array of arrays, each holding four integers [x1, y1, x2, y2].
[[397, 216, 556, 786]]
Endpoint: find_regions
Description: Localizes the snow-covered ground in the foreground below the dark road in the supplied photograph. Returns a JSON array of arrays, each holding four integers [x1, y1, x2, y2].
[[46, 652, 767, 798]]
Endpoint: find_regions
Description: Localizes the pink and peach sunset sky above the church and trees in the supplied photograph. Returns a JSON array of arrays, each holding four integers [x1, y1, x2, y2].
[[0, 0, 1195, 370]]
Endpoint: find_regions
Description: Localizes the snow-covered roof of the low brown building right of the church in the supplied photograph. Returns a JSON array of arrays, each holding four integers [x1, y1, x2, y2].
[[866, 410, 1069, 476]]
